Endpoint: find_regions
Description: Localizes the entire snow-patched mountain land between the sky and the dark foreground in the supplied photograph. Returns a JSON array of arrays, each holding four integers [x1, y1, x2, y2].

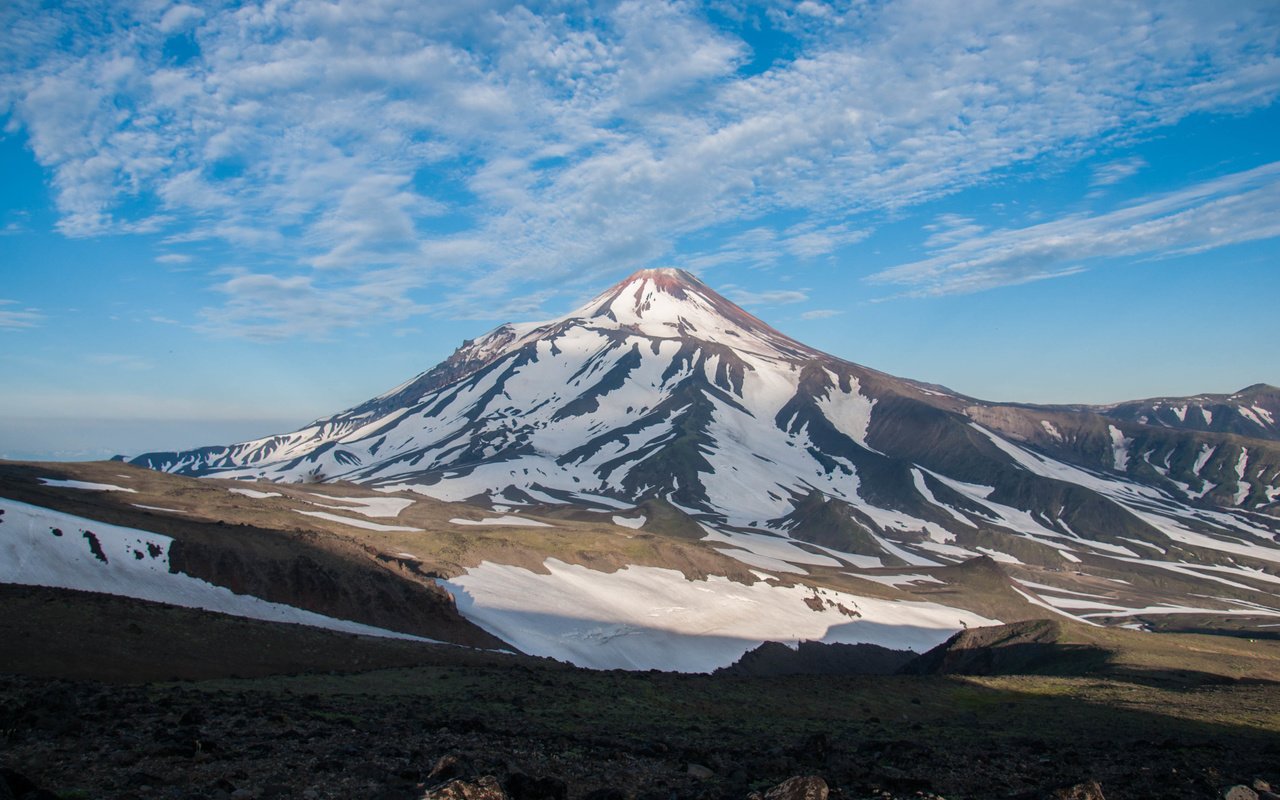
[[0, 269, 1280, 672]]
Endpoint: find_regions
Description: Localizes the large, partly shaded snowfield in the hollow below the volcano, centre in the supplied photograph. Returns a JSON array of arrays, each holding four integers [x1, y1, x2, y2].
[[442, 559, 996, 672]]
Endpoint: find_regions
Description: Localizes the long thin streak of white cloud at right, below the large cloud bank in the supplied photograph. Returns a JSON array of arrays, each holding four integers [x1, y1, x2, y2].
[[870, 161, 1280, 296]]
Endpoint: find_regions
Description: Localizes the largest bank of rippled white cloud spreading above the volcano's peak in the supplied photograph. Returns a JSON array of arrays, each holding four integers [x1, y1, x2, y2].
[[0, 0, 1280, 338]]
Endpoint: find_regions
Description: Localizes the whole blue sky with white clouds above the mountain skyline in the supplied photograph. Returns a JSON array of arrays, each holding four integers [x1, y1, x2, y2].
[[0, 0, 1280, 458]]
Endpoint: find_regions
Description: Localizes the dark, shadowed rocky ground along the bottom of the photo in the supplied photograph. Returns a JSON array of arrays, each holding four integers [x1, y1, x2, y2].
[[0, 614, 1280, 800]]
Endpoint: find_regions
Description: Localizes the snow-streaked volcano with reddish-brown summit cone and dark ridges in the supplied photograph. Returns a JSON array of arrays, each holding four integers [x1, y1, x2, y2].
[[134, 269, 1280, 585]]
